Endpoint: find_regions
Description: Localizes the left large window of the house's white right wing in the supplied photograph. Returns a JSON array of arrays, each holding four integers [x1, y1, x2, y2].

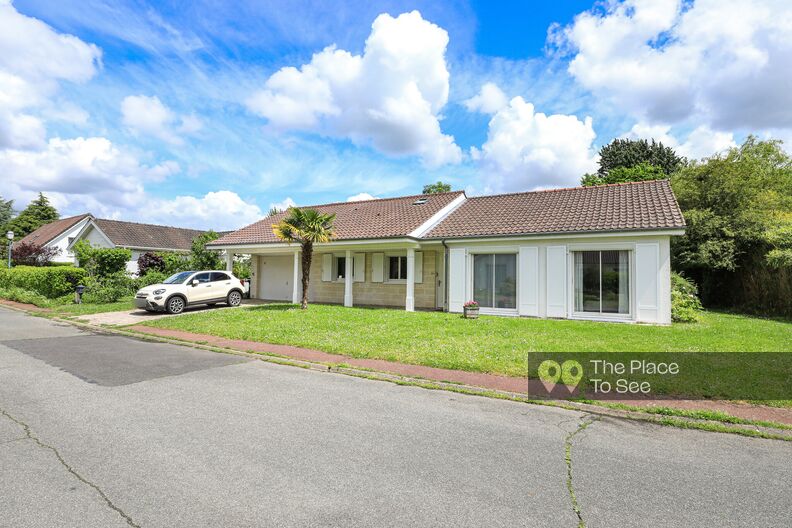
[[473, 253, 517, 309]]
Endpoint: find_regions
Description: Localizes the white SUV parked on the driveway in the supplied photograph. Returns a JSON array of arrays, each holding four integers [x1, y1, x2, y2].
[[135, 270, 244, 314]]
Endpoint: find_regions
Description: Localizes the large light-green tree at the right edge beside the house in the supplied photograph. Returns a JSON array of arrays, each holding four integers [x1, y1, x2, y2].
[[672, 136, 792, 314]]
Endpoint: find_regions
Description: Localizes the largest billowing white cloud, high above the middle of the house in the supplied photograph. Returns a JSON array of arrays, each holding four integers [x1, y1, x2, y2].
[[247, 11, 462, 166]]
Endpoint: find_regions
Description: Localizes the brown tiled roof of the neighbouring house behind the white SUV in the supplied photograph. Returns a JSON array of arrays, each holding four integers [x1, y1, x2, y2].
[[94, 218, 209, 250]]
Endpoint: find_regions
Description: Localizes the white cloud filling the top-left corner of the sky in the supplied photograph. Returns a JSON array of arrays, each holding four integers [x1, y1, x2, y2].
[[0, 0, 101, 148]]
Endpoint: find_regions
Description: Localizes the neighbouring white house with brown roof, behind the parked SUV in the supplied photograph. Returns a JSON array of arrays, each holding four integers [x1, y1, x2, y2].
[[68, 215, 210, 274]]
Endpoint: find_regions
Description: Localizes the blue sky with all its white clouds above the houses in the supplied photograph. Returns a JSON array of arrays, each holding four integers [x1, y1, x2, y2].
[[0, 0, 792, 229]]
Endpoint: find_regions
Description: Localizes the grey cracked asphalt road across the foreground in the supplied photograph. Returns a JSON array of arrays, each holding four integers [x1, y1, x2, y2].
[[0, 308, 792, 528]]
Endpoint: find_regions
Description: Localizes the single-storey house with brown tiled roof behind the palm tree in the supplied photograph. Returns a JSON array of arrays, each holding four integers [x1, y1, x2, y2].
[[208, 180, 685, 324]]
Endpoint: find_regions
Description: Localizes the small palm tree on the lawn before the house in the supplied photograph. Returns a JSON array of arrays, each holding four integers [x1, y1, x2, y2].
[[272, 207, 335, 310]]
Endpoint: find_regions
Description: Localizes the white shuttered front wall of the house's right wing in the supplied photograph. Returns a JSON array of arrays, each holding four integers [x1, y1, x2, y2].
[[447, 233, 677, 324]]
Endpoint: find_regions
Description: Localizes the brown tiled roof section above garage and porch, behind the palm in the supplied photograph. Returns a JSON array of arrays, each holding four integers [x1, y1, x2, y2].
[[210, 191, 462, 245]]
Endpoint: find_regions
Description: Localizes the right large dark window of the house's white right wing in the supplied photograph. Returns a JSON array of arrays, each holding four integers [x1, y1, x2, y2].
[[574, 251, 630, 314]]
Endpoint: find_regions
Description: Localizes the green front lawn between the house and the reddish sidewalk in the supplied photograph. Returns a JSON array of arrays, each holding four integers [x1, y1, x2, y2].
[[146, 304, 792, 376]]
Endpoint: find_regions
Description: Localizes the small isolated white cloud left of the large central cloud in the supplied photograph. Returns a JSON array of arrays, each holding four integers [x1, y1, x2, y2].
[[121, 95, 203, 145]]
